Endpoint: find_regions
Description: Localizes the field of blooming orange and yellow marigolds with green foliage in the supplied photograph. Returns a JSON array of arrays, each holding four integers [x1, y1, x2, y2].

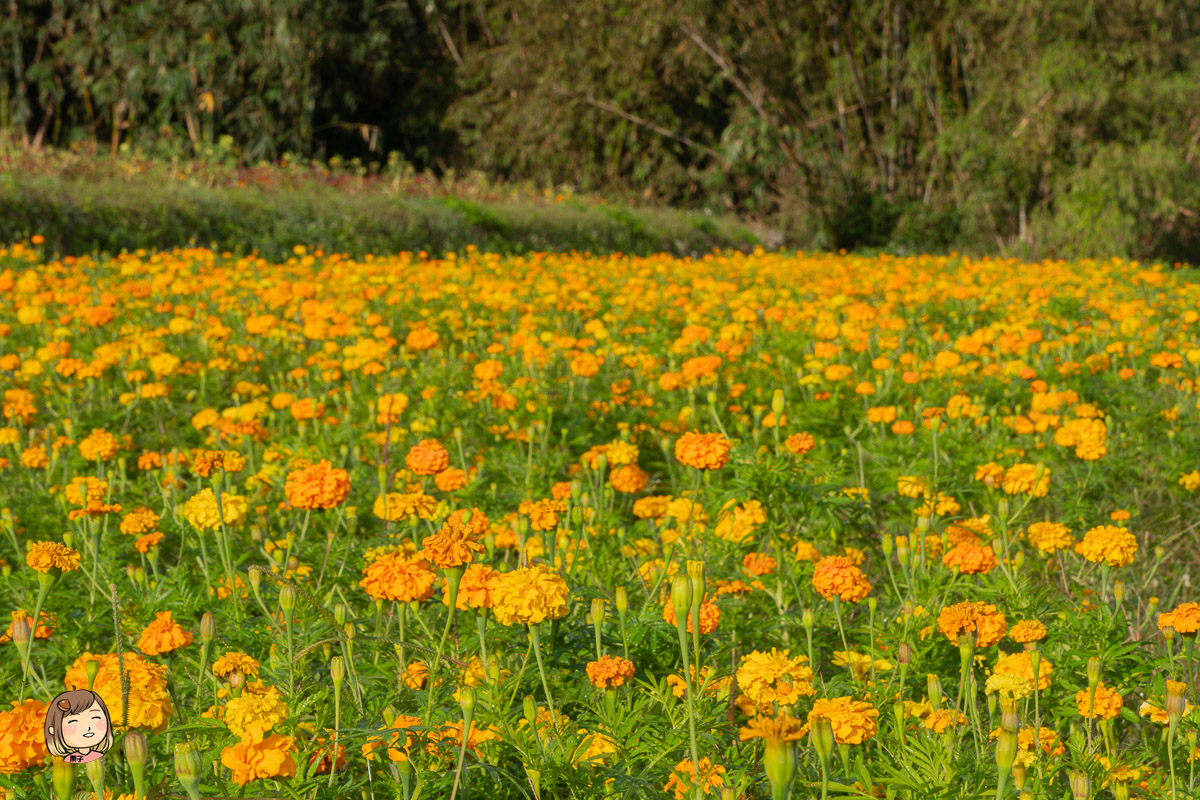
[[0, 244, 1200, 800]]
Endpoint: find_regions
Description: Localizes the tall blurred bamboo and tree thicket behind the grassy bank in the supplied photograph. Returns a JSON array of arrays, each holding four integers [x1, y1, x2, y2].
[[0, 0, 1200, 263]]
